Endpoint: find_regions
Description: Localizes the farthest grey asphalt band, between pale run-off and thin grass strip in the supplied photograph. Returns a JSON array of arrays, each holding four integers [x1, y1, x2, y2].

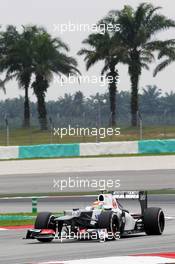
[[0, 169, 175, 194]]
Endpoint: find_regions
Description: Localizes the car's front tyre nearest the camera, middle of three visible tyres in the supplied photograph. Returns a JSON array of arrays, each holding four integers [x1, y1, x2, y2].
[[98, 211, 119, 239]]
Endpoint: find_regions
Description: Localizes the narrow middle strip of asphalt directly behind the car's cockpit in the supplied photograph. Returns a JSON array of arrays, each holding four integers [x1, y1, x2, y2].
[[0, 195, 175, 214]]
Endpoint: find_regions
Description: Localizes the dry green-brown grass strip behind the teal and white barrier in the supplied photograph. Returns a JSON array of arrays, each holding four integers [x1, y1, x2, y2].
[[0, 126, 175, 146]]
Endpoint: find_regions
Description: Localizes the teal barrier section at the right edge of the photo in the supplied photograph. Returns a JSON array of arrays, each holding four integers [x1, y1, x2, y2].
[[138, 139, 175, 153]]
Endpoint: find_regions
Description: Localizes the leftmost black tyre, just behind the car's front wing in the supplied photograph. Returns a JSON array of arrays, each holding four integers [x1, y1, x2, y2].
[[34, 212, 55, 242]]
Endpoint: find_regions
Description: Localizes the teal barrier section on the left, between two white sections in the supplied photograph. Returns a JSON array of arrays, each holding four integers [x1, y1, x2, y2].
[[19, 144, 80, 159]]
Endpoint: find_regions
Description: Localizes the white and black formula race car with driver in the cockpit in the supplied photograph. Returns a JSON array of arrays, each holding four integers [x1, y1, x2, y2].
[[26, 191, 165, 242]]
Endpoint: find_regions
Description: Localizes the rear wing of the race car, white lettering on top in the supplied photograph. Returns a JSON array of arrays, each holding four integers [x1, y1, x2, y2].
[[112, 191, 148, 214]]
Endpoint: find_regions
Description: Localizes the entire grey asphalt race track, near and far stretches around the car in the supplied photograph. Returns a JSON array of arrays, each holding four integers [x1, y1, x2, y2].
[[0, 170, 175, 264]]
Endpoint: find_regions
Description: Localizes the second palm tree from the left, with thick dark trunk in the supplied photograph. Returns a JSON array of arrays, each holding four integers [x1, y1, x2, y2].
[[32, 29, 79, 130]]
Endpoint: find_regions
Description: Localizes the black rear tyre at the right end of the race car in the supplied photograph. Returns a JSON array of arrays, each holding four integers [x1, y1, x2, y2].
[[143, 207, 165, 235]]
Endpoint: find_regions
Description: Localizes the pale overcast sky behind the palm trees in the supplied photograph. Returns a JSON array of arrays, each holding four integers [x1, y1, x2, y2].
[[0, 0, 175, 101]]
